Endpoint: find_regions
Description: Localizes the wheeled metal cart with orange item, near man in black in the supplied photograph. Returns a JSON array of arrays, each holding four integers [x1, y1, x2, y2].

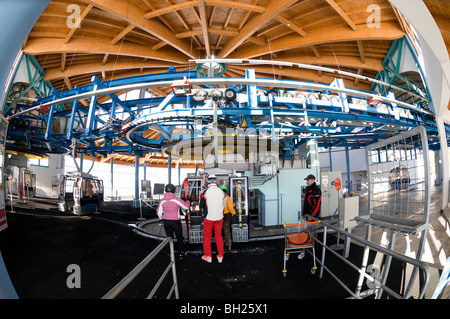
[[283, 221, 320, 277]]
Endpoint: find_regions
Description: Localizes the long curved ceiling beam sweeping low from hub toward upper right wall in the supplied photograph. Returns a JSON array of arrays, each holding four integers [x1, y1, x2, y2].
[[229, 23, 405, 59]]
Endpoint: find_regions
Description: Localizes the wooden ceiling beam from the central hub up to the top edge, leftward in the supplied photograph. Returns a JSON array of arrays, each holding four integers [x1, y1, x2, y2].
[[83, 0, 197, 59]]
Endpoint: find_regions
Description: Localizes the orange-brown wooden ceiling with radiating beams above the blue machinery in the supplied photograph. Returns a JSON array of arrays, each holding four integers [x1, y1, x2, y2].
[[18, 0, 448, 165]]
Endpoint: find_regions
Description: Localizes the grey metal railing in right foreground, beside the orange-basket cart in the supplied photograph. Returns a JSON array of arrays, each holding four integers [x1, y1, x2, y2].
[[307, 215, 430, 299]]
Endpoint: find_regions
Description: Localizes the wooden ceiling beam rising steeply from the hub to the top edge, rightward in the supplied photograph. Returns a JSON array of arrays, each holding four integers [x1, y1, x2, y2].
[[218, 0, 298, 58]]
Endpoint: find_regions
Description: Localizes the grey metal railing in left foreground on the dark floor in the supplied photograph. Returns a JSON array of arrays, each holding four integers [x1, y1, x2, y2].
[[102, 237, 180, 299]]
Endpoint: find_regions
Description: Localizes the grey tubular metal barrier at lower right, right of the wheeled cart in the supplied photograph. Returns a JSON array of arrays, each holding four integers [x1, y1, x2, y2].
[[308, 216, 430, 299]]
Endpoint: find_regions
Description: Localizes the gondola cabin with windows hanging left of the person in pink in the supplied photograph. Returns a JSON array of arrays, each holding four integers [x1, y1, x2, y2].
[[58, 172, 103, 215]]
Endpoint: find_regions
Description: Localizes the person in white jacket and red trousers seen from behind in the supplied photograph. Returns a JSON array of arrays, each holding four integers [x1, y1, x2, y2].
[[200, 175, 227, 263]]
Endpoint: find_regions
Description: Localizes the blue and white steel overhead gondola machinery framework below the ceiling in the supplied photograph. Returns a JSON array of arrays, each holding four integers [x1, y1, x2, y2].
[[0, 52, 450, 162]]
